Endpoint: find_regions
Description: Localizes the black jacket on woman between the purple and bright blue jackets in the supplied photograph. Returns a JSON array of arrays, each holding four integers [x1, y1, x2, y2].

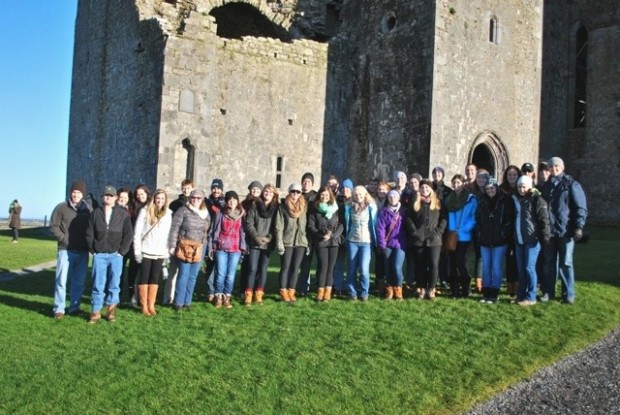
[[406, 203, 447, 246]]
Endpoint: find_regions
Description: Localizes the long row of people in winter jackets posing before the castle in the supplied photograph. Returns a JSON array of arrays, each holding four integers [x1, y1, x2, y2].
[[50, 157, 587, 323]]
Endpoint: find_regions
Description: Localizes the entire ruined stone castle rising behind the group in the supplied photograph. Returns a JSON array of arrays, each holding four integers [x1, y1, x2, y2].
[[67, 0, 620, 218]]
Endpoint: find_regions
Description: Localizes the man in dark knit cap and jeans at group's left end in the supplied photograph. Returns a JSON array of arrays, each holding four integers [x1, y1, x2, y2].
[[50, 180, 92, 320]]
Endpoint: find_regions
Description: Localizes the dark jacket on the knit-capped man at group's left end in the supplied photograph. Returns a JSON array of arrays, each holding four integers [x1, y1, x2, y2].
[[50, 199, 92, 252]]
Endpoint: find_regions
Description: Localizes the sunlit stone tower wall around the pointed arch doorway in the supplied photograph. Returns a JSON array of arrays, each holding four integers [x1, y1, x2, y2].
[[432, 0, 542, 179]]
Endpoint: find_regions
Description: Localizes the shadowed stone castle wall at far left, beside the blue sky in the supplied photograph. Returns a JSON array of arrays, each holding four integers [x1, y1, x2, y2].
[[67, 0, 163, 197]]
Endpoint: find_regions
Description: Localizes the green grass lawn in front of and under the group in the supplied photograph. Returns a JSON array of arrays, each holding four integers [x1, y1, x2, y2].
[[0, 228, 620, 414]]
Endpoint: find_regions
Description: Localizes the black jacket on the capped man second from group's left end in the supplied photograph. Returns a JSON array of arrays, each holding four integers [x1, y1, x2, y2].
[[86, 206, 133, 256]]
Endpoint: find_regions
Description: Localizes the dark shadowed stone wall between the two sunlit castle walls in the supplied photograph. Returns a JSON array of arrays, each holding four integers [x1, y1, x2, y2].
[[324, 0, 434, 183]]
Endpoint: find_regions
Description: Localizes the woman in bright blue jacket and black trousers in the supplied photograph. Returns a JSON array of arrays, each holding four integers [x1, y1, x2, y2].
[[445, 174, 478, 298]]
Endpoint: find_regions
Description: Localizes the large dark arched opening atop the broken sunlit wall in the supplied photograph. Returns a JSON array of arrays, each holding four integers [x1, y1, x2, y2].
[[209, 3, 292, 42]]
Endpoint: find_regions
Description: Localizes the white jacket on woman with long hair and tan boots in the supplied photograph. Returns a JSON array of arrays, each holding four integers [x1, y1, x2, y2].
[[133, 207, 172, 258]]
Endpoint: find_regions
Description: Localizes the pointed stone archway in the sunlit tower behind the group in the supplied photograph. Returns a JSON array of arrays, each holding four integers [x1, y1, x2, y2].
[[467, 131, 510, 179]]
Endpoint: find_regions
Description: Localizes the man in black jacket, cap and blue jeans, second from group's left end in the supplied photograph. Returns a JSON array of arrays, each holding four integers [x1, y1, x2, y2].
[[86, 186, 133, 324]]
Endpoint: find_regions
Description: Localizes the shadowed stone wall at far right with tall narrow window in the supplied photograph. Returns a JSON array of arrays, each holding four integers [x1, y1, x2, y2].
[[540, 0, 620, 222]]
